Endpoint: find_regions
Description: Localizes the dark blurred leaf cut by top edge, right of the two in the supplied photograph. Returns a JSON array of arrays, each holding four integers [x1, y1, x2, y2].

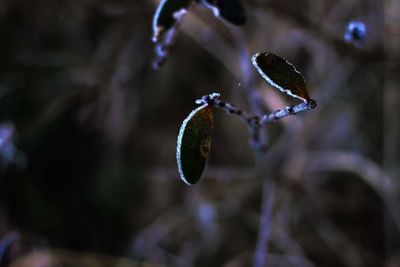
[[202, 0, 246, 26]]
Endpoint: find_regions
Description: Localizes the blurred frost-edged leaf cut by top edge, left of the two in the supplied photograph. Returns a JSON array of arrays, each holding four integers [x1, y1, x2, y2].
[[153, 0, 192, 43]]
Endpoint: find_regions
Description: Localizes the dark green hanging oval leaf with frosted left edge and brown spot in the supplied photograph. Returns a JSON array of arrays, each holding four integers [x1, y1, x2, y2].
[[176, 104, 214, 185]]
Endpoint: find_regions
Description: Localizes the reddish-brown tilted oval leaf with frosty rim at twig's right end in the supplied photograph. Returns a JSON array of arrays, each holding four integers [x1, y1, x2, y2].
[[251, 52, 310, 102]]
